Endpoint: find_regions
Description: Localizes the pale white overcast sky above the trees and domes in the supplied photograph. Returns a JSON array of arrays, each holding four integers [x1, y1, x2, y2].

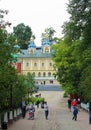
[[0, 0, 69, 46]]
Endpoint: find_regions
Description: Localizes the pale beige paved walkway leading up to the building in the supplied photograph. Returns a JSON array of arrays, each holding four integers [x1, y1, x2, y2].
[[8, 91, 91, 130]]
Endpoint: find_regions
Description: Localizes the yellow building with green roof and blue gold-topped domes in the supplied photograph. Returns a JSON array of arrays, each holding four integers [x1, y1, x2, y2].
[[18, 35, 57, 84]]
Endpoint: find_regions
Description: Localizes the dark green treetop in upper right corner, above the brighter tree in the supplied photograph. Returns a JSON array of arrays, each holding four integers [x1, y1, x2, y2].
[[63, 0, 91, 45]]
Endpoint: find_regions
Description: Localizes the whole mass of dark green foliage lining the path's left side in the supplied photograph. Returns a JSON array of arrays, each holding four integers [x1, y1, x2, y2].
[[0, 10, 33, 110]]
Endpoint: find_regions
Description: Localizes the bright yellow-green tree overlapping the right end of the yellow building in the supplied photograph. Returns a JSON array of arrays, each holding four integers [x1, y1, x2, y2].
[[53, 40, 80, 92]]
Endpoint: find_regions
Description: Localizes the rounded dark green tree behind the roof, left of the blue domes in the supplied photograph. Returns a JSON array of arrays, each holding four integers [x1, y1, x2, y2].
[[13, 23, 32, 49]]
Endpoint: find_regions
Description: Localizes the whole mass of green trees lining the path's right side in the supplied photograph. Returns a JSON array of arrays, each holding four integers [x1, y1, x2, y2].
[[53, 0, 91, 101]]
